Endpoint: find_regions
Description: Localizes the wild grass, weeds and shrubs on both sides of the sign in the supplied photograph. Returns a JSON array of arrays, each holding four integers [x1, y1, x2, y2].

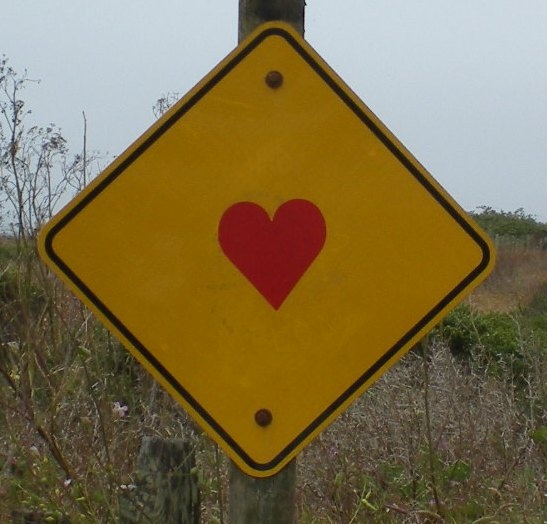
[[0, 60, 547, 524]]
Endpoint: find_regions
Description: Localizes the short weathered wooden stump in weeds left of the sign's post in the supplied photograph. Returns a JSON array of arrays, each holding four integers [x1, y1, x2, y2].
[[119, 437, 200, 524]]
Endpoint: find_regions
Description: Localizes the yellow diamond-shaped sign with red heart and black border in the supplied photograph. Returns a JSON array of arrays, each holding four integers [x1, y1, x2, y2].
[[36, 24, 493, 476]]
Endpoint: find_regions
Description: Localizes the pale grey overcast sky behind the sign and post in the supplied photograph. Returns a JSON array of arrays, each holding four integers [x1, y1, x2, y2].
[[0, 0, 547, 221]]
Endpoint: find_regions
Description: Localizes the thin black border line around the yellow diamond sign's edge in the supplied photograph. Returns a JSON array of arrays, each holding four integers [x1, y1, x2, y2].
[[44, 27, 490, 472]]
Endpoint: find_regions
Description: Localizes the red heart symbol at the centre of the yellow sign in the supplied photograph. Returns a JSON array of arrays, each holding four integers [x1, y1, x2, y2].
[[218, 199, 327, 310]]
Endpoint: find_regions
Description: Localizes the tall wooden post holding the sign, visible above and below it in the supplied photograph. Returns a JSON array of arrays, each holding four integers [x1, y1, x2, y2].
[[229, 0, 306, 524]]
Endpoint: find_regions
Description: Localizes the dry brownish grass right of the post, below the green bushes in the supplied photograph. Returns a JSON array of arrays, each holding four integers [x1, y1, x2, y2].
[[299, 345, 547, 523]]
